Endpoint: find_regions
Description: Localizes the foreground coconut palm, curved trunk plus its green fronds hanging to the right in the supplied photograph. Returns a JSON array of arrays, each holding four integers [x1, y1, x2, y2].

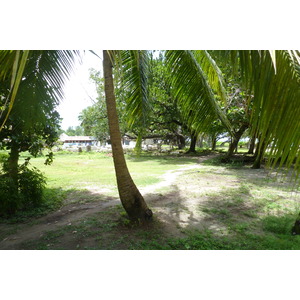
[[103, 50, 236, 220]]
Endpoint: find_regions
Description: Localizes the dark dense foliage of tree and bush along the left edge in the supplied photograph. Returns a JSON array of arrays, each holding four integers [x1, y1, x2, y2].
[[0, 51, 77, 215]]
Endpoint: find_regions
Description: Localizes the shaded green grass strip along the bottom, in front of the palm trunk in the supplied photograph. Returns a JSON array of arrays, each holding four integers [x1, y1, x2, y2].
[[15, 207, 300, 250]]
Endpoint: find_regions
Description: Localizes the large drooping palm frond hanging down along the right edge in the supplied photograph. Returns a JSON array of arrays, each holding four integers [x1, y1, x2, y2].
[[225, 50, 300, 173]]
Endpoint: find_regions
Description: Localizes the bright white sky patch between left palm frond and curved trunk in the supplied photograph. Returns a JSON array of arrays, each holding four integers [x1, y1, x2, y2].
[[57, 51, 102, 130]]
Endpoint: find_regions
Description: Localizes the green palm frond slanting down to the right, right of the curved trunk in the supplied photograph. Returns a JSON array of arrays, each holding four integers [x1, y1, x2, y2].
[[166, 50, 233, 134]]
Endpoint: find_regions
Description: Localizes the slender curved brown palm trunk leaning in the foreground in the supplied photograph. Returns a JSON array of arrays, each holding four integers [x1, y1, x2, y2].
[[103, 50, 152, 220]]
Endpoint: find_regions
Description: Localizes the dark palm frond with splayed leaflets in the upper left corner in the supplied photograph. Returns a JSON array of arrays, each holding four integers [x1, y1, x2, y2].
[[0, 50, 80, 131]]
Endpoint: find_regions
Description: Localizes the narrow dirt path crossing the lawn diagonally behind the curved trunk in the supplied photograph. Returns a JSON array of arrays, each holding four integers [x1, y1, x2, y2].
[[0, 156, 216, 249]]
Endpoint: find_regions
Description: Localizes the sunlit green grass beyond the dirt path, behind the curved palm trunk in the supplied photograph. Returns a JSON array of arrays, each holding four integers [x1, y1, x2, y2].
[[0, 151, 195, 223]]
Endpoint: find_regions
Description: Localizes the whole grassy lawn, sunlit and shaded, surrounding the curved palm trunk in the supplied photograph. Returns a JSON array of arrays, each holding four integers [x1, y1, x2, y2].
[[0, 153, 300, 250]]
